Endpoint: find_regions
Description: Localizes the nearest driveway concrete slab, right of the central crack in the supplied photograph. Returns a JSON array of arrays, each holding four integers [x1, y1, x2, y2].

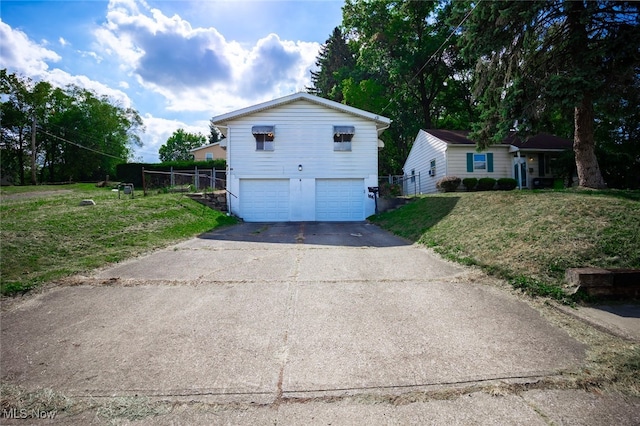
[[283, 282, 584, 397]]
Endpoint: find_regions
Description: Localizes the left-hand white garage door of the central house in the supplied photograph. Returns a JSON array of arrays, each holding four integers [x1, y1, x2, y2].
[[240, 179, 289, 222]]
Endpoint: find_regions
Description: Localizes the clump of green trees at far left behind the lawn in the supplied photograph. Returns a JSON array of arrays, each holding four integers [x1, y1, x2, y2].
[[0, 70, 144, 184]]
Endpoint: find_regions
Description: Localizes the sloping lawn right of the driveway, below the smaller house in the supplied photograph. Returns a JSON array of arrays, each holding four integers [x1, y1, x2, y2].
[[370, 190, 640, 299]]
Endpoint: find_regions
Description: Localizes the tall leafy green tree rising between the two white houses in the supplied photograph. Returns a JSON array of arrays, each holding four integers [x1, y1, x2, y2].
[[332, 0, 475, 174]]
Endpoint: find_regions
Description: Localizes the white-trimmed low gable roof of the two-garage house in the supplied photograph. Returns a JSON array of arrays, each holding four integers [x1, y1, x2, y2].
[[211, 92, 391, 136]]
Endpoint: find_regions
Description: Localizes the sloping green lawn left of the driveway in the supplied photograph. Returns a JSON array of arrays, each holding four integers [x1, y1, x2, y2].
[[0, 184, 235, 295]]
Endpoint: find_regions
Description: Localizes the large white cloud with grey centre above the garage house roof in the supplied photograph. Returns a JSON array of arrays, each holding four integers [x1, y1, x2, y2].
[[95, 0, 320, 114]]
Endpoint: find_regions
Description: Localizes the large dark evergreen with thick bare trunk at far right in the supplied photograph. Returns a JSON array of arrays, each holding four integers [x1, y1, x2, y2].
[[456, 0, 640, 188]]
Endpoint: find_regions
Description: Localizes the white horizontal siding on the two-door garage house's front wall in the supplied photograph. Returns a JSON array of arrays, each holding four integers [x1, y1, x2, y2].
[[226, 100, 378, 220]]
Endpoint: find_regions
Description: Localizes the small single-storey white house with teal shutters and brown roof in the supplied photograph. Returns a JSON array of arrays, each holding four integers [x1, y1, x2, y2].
[[403, 129, 573, 195]]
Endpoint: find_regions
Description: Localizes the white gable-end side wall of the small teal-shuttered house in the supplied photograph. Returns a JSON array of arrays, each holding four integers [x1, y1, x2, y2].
[[403, 130, 447, 195]]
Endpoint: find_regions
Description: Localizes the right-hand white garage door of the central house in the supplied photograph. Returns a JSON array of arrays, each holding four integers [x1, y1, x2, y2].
[[316, 179, 366, 221]]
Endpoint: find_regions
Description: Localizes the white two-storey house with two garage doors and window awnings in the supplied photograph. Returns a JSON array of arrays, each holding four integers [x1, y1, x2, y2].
[[212, 93, 391, 222]]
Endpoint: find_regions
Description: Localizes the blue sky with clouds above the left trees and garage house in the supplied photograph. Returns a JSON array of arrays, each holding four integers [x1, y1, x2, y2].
[[0, 0, 344, 162]]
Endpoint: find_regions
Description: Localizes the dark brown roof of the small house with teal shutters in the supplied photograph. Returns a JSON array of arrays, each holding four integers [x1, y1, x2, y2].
[[424, 129, 573, 150]]
